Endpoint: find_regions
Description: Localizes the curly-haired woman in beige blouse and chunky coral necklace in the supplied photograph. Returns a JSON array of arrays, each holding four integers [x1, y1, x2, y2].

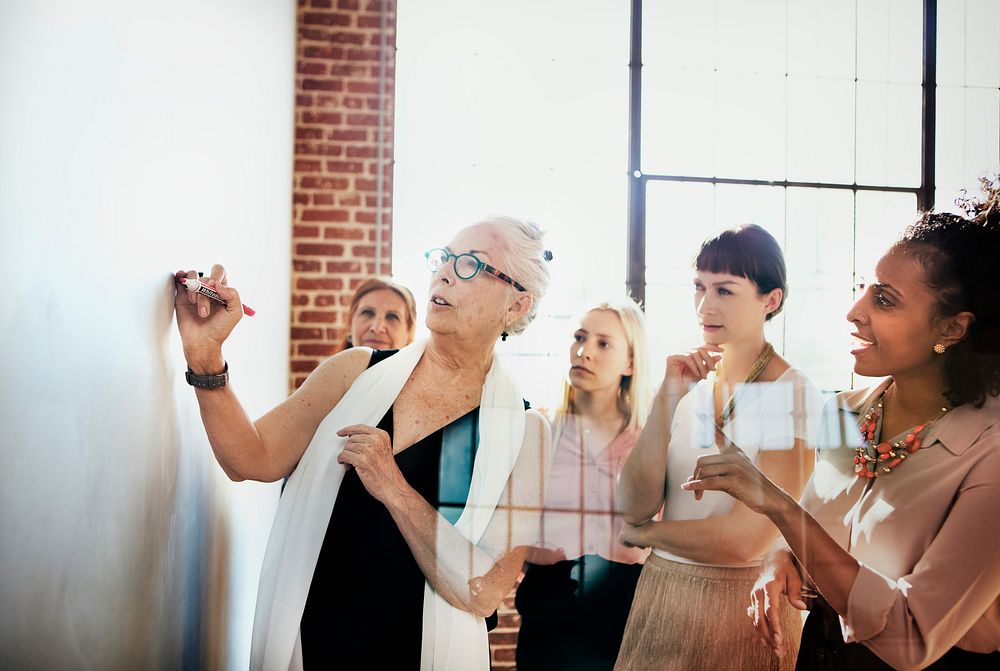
[[684, 177, 1000, 671]]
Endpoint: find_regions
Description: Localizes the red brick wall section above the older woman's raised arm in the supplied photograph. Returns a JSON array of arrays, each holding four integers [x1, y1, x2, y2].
[[289, 0, 396, 389]]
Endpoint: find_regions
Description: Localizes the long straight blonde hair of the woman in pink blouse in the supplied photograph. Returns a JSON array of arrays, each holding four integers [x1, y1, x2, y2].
[[556, 298, 653, 431]]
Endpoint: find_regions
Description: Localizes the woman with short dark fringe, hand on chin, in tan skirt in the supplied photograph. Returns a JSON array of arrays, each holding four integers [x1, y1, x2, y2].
[[615, 224, 822, 671]]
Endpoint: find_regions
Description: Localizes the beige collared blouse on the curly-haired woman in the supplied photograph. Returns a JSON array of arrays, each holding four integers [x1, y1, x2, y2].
[[802, 381, 1000, 669]]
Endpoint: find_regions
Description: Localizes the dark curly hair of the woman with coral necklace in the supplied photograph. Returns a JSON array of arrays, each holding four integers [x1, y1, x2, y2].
[[896, 181, 1000, 408]]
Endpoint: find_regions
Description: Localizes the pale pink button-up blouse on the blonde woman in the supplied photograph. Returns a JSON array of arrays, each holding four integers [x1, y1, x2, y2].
[[541, 416, 649, 564]]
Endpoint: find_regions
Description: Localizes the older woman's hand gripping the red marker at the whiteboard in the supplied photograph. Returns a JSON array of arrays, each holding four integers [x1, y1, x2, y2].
[[174, 264, 243, 374]]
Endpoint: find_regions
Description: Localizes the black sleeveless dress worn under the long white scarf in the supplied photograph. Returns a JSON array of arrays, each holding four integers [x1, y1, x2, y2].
[[300, 350, 479, 669]]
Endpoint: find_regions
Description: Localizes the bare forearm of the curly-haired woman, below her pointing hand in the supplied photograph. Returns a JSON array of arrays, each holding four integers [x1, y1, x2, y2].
[[768, 492, 861, 616]]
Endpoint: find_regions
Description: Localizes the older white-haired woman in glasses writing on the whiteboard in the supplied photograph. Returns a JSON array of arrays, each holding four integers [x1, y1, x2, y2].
[[175, 218, 550, 670]]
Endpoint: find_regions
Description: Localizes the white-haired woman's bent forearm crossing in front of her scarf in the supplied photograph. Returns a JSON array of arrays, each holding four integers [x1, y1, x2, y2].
[[384, 482, 527, 617]]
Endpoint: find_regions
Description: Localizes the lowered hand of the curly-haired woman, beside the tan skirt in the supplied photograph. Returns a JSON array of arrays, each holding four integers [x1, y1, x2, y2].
[[747, 549, 808, 657]]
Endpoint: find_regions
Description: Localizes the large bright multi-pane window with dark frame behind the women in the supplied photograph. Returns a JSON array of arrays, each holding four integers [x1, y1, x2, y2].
[[393, 0, 1000, 405]]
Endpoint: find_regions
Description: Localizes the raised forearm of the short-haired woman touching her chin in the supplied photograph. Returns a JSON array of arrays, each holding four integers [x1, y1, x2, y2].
[[616, 385, 677, 524]]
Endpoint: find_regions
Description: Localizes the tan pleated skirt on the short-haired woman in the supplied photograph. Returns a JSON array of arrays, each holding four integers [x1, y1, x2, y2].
[[615, 554, 802, 671]]
